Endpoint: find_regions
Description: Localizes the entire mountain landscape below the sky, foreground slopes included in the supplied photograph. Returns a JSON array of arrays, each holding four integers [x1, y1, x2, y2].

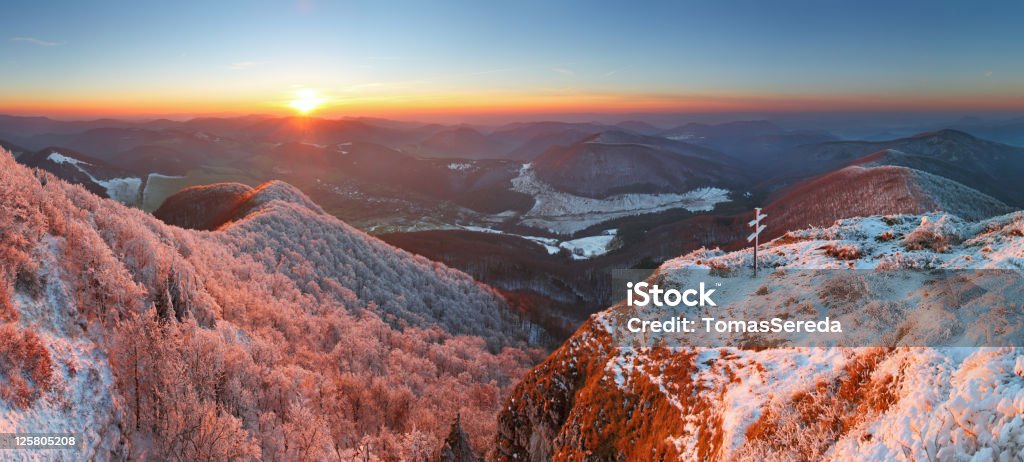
[[0, 110, 1024, 460]]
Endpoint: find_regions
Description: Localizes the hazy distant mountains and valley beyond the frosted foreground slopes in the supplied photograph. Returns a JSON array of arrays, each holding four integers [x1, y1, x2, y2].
[[9, 116, 1024, 344]]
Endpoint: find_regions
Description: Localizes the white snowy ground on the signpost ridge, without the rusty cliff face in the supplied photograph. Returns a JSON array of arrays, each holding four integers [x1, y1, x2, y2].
[[584, 212, 1024, 461]]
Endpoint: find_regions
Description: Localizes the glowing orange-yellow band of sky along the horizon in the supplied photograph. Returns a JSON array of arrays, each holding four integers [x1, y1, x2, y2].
[[0, 92, 1024, 120]]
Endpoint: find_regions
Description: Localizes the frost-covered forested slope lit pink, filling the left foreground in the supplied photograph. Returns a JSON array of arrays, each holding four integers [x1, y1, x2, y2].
[[0, 153, 537, 460]]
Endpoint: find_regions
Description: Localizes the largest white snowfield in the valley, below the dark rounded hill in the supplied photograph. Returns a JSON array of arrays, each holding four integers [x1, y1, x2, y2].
[[512, 164, 729, 235]]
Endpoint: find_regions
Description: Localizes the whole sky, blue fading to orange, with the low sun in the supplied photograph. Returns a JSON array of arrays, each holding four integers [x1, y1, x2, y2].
[[0, 0, 1024, 118]]
